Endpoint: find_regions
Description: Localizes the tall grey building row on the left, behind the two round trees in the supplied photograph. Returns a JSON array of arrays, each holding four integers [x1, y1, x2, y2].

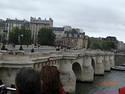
[[0, 17, 53, 43]]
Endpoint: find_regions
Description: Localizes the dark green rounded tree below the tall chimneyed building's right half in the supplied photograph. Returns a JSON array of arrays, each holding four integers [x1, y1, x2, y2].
[[38, 28, 55, 45]]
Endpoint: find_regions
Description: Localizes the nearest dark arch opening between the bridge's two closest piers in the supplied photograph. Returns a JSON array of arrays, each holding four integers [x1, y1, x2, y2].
[[72, 62, 82, 80]]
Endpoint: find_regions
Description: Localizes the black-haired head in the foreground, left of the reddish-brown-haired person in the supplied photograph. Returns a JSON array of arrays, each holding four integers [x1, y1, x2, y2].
[[15, 68, 42, 94]]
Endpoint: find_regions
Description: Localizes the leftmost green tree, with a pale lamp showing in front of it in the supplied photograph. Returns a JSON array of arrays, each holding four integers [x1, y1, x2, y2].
[[9, 27, 31, 45]]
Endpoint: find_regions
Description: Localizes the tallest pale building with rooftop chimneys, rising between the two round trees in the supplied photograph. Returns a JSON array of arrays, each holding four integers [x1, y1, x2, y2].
[[30, 17, 53, 44]]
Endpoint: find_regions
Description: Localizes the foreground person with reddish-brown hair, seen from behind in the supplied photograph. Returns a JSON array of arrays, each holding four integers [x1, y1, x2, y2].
[[41, 66, 66, 94]]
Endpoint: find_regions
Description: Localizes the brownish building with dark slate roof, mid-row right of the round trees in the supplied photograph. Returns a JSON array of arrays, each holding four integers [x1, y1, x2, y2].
[[63, 29, 88, 49]]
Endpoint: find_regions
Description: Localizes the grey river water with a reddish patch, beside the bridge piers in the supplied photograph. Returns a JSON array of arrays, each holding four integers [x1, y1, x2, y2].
[[75, 71, 125, 94]]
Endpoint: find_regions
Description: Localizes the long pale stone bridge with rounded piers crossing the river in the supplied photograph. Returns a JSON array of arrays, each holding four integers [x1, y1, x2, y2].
[[0, 50, 115, 92]]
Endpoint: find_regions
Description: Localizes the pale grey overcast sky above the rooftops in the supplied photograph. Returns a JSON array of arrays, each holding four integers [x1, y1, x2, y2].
[[0, 0, 125, 42]]
